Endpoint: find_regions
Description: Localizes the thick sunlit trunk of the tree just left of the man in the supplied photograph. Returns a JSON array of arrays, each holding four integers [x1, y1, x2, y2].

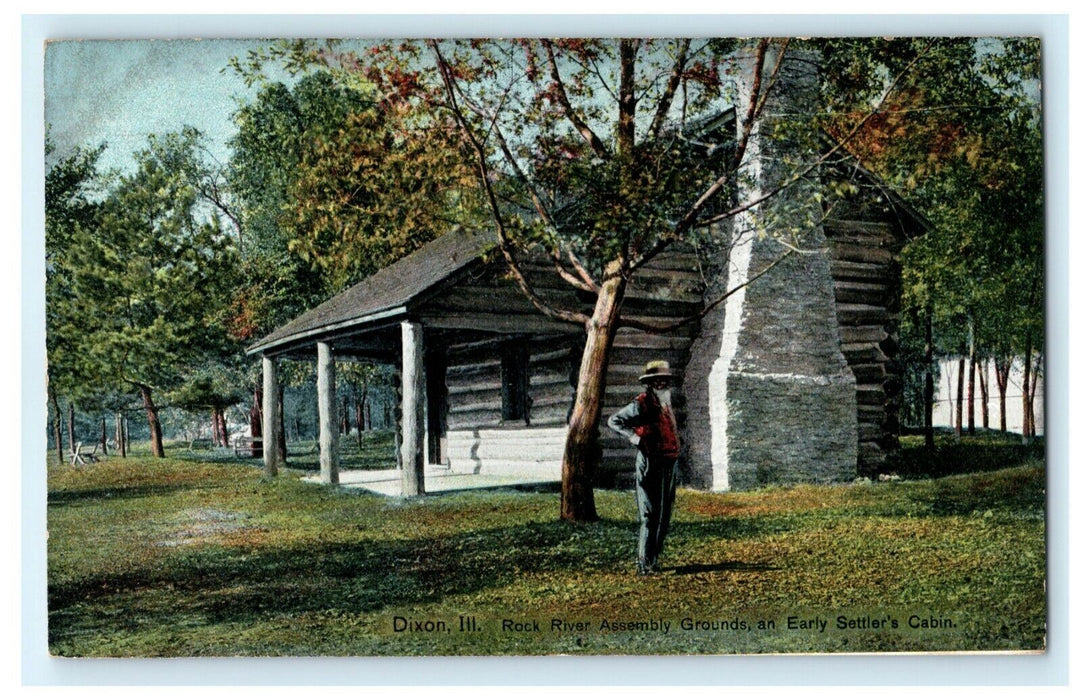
[[560, 262, 627, 522]]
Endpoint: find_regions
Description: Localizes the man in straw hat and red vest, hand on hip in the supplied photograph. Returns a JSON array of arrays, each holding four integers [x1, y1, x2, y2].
[[609, 360, 680, 575]]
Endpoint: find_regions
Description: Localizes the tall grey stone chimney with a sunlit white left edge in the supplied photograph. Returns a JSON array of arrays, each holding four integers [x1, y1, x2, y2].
[[683, 45, 858, 491]]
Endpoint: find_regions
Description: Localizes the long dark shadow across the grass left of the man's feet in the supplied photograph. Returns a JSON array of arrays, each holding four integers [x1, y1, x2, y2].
[[49, 522, 635, 633]]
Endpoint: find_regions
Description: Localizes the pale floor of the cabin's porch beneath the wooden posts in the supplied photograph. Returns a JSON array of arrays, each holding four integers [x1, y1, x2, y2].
[[302, 465, 560, 497]]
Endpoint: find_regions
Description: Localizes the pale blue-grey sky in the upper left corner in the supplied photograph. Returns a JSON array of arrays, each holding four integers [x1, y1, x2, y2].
[[44, 39, 283, 174]]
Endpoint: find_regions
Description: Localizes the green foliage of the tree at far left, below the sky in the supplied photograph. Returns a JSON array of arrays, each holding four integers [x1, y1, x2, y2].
[[48, 133, 235, 403]]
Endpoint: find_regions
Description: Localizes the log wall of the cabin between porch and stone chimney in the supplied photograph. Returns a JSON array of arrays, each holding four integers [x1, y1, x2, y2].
[[421, 249, 703, 485]]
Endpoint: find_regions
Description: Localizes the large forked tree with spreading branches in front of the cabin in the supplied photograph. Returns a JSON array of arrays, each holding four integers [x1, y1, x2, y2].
[[363, 39, 931, 521]]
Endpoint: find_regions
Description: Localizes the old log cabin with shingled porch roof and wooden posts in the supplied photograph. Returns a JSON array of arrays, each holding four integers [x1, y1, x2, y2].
[[248, 163, 923, 495]]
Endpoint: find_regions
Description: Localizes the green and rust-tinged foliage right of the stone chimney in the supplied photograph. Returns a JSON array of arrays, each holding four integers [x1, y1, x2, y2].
[[823, 38, 1044, 424]]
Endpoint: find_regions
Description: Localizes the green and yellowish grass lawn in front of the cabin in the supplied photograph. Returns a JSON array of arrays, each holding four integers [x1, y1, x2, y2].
[[48, 438, 1046, 657]]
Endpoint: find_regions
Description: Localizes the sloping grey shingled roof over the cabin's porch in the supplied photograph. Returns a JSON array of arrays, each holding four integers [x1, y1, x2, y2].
[[247, 230, 496, 354]]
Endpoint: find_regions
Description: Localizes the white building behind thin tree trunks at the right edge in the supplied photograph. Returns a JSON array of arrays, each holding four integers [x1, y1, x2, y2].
[[932, 359, 1045, 435]]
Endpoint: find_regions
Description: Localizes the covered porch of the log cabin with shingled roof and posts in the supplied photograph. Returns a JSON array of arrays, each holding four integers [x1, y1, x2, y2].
[[248, 227, 580, 497]]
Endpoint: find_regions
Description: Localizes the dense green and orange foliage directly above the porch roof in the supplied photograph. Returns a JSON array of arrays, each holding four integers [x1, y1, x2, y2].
[[230, 69, 472, 339]]
